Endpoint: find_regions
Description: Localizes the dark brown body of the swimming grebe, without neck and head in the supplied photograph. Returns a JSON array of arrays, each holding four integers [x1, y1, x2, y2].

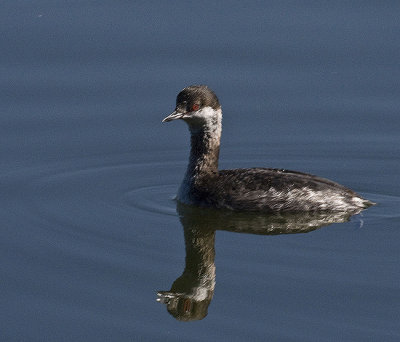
[[191, 168, 372, 212]]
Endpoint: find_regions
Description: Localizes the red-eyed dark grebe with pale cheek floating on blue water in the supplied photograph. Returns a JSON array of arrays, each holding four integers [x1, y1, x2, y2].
[[163, 85, 373, 212]]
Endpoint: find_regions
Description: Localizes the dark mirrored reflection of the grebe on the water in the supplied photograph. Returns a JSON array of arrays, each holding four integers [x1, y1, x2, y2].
[[157, 203, 361, 321]]
